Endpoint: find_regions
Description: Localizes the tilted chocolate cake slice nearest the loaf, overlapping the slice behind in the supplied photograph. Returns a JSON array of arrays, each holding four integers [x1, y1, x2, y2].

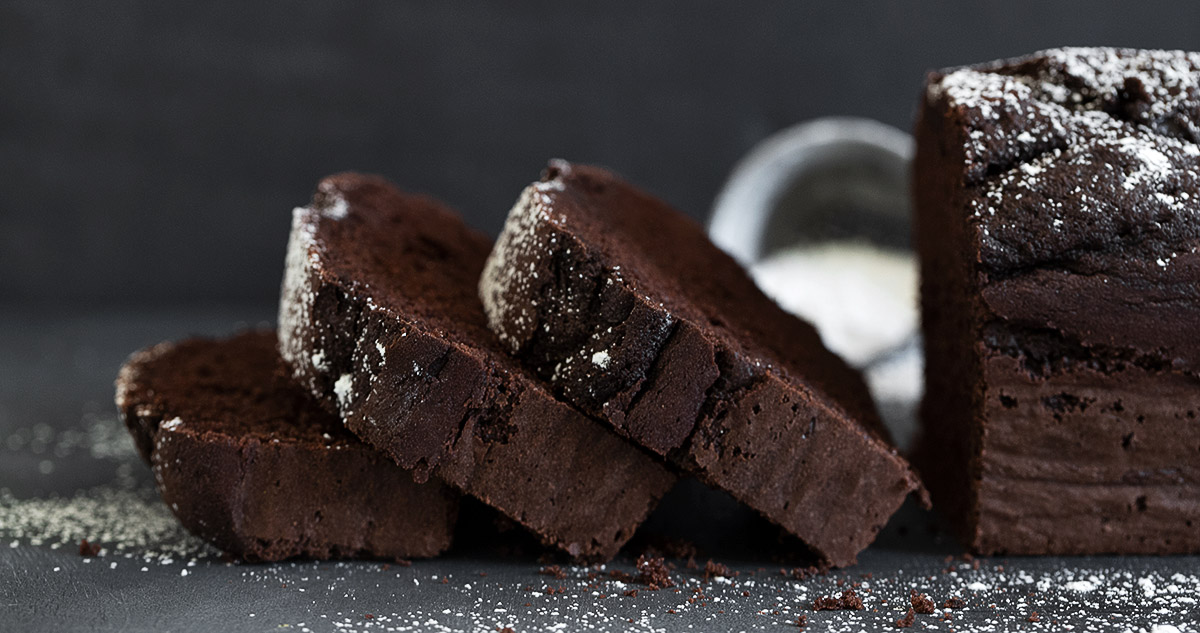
[[479, 161, 920, 566]]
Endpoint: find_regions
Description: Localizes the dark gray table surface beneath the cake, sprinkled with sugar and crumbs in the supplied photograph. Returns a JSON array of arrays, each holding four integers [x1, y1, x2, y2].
[[0, 306, 1200, 633]]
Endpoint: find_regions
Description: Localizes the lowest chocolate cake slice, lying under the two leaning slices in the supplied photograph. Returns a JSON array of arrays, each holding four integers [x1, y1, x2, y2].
[[116, 332, 457, 561]]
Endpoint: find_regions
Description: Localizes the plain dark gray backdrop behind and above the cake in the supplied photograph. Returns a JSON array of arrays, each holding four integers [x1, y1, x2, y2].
[[0, 0, 1200, 309]]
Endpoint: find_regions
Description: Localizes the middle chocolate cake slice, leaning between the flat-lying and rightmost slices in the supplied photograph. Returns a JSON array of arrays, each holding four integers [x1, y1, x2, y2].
[[280, 174, 674, 560]]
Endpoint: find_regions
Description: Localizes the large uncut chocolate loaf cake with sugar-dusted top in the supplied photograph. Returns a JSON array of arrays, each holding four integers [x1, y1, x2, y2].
[[914, 48, 1200, 554]]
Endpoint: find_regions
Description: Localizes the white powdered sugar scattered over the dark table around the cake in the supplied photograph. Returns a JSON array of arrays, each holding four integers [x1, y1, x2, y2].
[[0, 407, 1200, 633]]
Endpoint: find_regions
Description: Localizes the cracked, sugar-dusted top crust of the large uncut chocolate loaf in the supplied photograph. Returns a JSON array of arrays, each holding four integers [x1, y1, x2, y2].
[[926, 48, 1200, 275]]
